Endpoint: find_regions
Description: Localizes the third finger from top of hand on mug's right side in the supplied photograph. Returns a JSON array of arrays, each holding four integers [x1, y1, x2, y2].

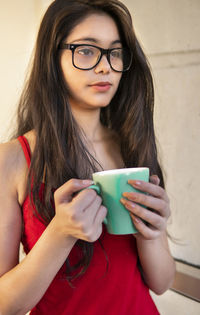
[[122, 199, 166, 230]]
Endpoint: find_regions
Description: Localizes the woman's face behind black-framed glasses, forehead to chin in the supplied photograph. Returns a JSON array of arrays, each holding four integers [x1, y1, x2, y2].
[[61, 14, 122, 109]]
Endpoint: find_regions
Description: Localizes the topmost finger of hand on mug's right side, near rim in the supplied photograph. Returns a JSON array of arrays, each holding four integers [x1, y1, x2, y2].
[[128, 179, 169, 202]]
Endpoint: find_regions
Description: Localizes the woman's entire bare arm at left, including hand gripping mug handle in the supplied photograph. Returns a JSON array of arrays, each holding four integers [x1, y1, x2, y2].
[[0, 145, 106, 315]]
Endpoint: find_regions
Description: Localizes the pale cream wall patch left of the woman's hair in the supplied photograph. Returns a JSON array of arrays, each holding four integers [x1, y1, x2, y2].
[[0, 0, 49, 141]]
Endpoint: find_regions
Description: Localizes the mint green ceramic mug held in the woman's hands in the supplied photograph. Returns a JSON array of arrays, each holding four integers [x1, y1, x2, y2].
[[88, 167, 149, 235]]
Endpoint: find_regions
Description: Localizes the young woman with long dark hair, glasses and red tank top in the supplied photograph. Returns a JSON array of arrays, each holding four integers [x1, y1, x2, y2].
[[0, 0, 175, 315]]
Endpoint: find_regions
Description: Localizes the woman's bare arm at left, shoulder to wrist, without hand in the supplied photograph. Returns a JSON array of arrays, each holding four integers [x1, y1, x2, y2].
[[0, 142, 74, 315]]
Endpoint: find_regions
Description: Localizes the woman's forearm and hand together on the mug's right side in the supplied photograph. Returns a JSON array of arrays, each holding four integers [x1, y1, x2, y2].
[[121, 176, 175, 294]]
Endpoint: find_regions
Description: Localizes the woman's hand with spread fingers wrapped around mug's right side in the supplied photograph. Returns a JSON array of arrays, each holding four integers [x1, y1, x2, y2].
[[120, 175, 171, 240]]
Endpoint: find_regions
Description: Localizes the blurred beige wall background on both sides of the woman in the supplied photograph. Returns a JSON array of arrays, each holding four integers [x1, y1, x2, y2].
[[0, 0, 200, 315]]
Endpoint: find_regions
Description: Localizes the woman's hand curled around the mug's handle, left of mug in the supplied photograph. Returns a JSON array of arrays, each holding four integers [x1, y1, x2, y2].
[[53, 179, 107, 242]]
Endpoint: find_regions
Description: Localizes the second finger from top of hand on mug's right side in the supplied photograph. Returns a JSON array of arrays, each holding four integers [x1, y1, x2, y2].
[[122, 192, 170, 217]]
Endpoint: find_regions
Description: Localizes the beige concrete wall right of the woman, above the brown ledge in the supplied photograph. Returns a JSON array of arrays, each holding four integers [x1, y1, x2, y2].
[[123, 0, 200, 264]]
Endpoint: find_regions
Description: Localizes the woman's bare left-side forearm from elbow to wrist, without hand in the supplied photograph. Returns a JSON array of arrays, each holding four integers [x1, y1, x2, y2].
[[0, 217, 76, 315]]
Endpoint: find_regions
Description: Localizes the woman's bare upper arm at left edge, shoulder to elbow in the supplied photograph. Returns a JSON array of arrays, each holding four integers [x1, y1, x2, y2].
[[0, 139, 26, 276]]
